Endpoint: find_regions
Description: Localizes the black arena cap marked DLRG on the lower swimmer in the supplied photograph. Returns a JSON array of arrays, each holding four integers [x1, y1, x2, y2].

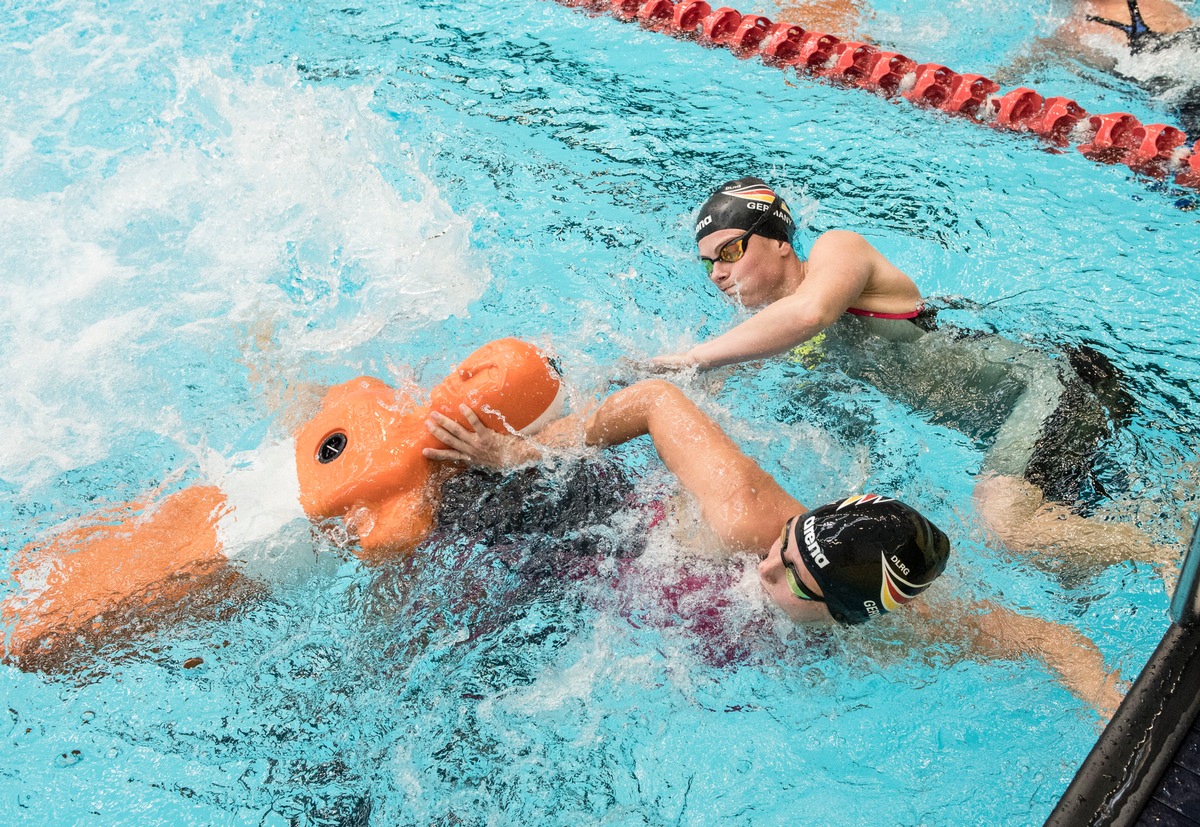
[[796, 493, 950, 623]]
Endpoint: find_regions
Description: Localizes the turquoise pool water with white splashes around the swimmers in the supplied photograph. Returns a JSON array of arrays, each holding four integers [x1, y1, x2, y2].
[[0, 0, 1200, 825]]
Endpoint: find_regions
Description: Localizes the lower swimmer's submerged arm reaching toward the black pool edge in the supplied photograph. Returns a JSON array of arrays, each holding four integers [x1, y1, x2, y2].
[[964, 601, 1124, 720]]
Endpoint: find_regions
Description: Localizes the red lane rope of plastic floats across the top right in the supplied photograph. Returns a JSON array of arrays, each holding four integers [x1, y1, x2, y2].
[[559, 0, 1200, 188]]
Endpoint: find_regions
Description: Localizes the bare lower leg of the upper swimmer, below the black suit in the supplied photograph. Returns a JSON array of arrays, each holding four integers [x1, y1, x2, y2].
[[974, 474, 1178, 565]]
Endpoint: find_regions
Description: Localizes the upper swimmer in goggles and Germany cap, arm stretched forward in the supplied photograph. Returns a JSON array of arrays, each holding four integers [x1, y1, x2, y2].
[[648, 178, 1166, 563]]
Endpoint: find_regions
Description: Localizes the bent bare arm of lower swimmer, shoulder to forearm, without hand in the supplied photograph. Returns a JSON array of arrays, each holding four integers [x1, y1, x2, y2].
[[584, 379, 804, 550]]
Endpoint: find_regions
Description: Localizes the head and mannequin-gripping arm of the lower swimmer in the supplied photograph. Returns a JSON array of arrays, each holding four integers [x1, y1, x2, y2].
[[425, 380, 950, 624]]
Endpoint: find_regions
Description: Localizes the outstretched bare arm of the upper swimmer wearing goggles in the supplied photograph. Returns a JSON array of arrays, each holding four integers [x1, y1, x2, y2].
[[654, 230, 877, 370]]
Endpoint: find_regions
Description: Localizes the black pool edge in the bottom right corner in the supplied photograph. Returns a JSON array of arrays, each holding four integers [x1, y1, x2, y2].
[[1045, 513, 1200, 827]]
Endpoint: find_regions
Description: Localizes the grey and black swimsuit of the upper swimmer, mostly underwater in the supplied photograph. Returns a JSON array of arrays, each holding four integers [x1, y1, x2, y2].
[[793, 304, 1118, 510]]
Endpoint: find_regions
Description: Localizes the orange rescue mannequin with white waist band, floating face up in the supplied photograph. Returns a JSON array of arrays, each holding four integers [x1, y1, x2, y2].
[[0, 338, 562, 659]]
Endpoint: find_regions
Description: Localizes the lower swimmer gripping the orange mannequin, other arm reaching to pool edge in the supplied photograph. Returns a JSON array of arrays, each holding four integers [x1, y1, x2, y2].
[[425, 379, 1121, 717]]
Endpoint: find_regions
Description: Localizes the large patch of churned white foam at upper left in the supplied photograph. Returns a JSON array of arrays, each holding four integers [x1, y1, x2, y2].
[[0, 51, 491, 486]]
